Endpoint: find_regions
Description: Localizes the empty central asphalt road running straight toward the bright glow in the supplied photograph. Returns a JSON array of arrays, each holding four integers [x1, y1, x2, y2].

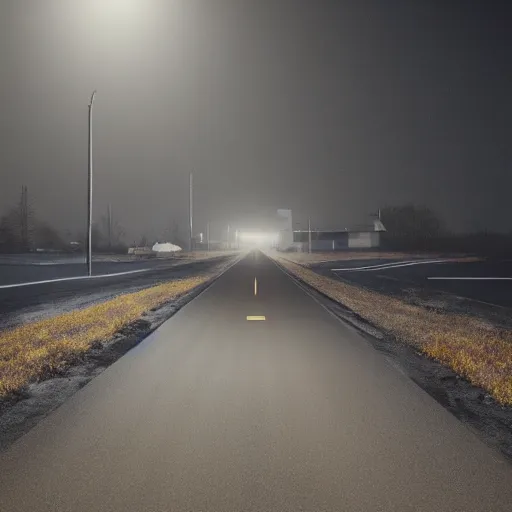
[[0, 253, 512, 512]]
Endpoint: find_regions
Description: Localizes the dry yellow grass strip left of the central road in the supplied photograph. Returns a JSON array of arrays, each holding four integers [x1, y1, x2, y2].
[[0, 276, 210, 397]]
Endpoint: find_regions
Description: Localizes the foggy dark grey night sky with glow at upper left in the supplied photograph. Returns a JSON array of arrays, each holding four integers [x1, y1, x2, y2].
[[0, 0, 512, 238]]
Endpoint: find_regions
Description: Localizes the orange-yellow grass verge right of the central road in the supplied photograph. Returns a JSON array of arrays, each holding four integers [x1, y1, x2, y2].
[[278, 258, 512, 406]]
